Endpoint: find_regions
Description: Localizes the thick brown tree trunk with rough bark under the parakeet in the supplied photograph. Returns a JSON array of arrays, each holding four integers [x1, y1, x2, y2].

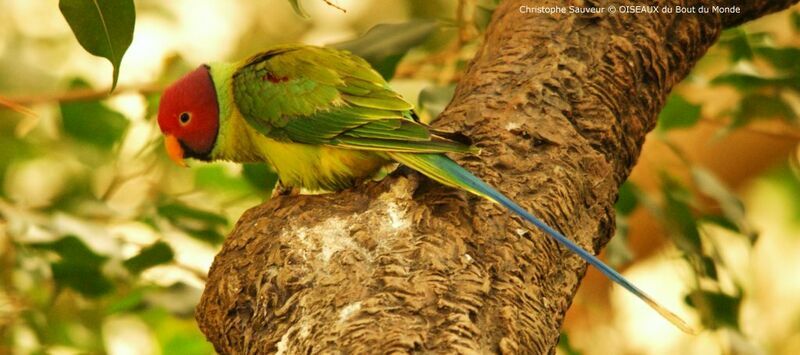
[[196, 0, 796, 354]]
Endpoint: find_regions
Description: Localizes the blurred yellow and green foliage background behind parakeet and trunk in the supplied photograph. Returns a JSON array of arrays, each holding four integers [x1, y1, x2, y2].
[[0, 0, 800, 354]]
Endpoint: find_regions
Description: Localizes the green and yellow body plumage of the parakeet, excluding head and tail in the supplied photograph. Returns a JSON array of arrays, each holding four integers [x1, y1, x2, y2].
[[211, 45, 477, 190]]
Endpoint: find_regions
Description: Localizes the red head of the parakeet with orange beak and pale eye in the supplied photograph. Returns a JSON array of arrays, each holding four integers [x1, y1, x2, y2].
[[158, 65, 219, 166]]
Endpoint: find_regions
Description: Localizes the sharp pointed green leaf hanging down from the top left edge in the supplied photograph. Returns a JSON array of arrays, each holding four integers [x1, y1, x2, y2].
[[58, 0, 136, 91]]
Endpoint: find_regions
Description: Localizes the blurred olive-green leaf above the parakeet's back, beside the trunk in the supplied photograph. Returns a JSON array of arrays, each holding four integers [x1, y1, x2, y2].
[[330, 19, 439, 80]]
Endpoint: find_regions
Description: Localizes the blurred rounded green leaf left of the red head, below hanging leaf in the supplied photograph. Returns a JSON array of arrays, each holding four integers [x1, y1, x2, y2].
[[61, 79, 129, 149]]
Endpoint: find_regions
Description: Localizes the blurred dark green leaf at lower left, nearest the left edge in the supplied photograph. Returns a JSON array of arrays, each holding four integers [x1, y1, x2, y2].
[[50, 259, 114, 297]]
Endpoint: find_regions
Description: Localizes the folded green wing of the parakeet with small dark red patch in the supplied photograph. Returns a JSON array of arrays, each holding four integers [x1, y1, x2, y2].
[[233, 45, 474, 153]]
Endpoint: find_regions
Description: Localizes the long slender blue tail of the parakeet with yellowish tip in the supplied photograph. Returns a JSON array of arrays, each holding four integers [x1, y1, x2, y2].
[[387, 153, 695, 334]]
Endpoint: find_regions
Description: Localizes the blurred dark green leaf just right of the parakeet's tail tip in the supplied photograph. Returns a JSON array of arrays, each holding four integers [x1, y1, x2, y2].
[[685, 290, 742, 329]]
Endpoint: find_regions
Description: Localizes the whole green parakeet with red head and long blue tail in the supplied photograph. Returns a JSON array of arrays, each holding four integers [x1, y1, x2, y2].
[[158, 45, 691, 331]]
